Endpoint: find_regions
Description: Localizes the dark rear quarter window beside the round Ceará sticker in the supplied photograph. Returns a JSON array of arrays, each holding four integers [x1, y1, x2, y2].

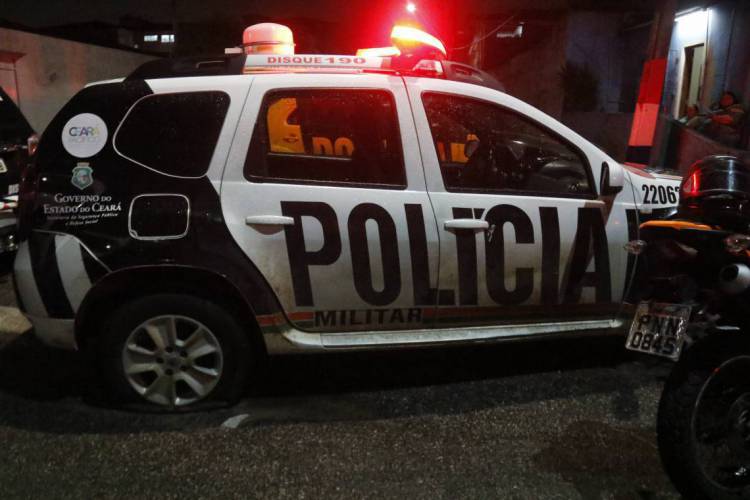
[[114, 91, 229, 177]]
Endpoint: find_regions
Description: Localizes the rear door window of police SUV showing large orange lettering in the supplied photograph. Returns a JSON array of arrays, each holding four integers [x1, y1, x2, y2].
[[245, 89, 406, 189]]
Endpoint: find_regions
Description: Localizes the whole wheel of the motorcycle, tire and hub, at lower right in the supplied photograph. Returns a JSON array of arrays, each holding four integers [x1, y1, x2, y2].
[[657, 336, 750, 499]]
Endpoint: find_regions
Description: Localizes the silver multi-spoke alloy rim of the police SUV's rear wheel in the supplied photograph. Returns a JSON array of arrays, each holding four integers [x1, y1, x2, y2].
[[122, 315, 224, 407]]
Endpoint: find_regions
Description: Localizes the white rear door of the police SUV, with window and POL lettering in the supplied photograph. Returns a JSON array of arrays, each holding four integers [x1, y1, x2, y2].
[[221, 74, 438, 331]]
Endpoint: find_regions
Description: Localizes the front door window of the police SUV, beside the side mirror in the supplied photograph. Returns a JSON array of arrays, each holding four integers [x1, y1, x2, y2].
[[422, 93, 594, 197]]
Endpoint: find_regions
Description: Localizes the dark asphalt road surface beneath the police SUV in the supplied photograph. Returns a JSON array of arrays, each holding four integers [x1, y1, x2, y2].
[[0, 277, 676, 499]]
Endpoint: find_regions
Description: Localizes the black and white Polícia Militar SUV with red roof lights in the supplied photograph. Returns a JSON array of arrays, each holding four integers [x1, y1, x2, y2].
[[14, 24, 679, 409]]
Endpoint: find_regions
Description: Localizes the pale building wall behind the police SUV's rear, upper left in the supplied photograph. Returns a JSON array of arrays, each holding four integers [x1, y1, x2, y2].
[[0, 28, 154, 132]]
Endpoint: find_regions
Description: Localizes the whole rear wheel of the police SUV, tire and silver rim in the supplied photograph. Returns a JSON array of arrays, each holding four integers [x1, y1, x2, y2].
[[100, 294, 254, 411]]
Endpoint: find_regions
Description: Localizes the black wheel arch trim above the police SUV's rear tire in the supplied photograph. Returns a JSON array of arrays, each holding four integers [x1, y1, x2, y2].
[[75, 265, 266, 353]]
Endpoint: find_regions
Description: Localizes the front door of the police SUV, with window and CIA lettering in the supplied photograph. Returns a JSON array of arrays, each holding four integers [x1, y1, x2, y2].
[[407, 78, 633, 333]]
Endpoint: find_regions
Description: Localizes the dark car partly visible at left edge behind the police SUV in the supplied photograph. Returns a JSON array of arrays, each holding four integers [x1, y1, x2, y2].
[[0, 87, 38, 274]]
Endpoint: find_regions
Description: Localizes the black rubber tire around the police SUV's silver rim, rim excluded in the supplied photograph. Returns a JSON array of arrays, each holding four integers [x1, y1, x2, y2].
[[95, 294, 261, 412]]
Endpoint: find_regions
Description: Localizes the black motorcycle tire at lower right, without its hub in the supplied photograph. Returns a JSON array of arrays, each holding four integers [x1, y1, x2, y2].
[[657, 337, 750, 499]]
